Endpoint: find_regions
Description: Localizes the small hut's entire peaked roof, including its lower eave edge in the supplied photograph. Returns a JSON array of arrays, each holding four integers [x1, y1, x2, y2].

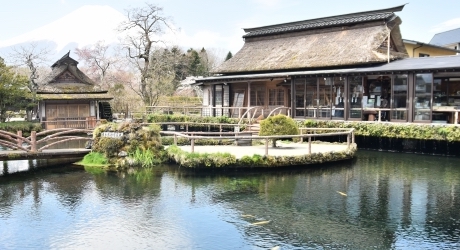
[[37, 51, 112, 100]]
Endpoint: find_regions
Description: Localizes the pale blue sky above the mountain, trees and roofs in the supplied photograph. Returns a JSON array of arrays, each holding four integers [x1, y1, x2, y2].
[[0, 0, 460, 53]]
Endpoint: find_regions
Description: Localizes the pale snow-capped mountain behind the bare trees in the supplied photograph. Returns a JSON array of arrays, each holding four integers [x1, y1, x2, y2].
[[0, 5, 126, 57]]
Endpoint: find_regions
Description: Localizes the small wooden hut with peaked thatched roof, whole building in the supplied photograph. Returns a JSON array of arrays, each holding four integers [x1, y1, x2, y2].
[[37, 51, 112, 129]]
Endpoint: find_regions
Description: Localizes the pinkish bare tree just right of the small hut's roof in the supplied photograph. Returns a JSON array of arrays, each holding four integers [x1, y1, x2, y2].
[[75, 41, 119, 88]]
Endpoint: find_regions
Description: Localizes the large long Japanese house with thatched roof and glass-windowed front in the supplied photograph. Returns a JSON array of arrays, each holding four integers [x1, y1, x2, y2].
[[195, 5, 460, 123]]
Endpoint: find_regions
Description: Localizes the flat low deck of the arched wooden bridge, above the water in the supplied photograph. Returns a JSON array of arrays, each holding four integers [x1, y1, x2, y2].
[[0, 148, 91, 161]]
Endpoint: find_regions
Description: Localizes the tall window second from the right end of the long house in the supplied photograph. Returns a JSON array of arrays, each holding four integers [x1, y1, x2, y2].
[[413, 74, 433, 121]]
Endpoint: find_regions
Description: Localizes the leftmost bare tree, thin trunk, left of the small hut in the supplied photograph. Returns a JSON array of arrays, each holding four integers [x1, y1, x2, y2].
[[10, 43, 51, 121]]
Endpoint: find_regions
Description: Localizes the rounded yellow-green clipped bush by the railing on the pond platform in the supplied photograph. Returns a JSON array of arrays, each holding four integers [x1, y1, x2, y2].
[[259, 114, 299, 147]]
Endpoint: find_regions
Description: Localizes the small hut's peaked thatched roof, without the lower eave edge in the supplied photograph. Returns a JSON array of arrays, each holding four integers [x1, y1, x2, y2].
[[38, 51, 103, 93]]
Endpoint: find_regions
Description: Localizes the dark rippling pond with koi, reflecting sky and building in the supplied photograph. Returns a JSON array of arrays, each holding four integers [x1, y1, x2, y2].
[[0, 150, 460, 249]]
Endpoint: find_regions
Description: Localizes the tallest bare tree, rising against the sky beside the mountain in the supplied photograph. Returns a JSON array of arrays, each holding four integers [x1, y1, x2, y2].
[[119, 3, 172, 105]]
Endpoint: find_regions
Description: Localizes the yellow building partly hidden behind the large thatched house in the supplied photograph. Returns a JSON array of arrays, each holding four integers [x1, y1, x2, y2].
[[403, 39, 460, 57]]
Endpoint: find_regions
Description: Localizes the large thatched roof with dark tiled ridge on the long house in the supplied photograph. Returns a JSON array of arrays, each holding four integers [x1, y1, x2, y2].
[[214, 6, 407, 74]]
